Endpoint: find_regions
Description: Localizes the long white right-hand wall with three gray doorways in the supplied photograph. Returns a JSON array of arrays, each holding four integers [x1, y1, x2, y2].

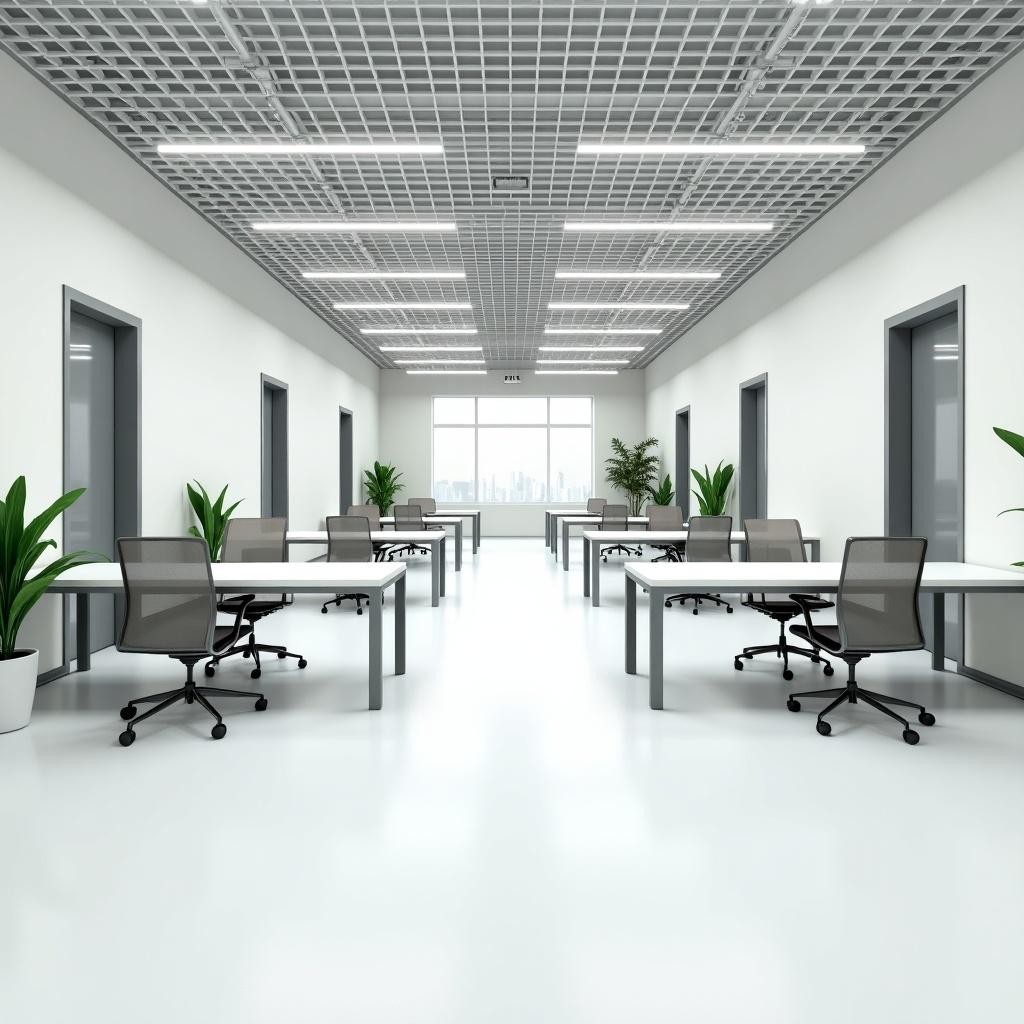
[[646, 49, 1024, 684]]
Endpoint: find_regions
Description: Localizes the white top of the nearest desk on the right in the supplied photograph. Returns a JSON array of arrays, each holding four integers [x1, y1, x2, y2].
[[618, 561, 1024, 594]]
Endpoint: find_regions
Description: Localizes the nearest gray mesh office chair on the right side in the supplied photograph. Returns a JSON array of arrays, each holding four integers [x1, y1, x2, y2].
[[785, 537, 935, 746]]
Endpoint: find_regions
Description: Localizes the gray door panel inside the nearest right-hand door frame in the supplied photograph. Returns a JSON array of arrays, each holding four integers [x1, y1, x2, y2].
[[910, 313, 963, 662]]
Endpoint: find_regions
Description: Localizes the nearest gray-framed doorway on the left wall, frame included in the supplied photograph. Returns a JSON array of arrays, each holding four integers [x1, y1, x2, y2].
[[61, 288, 140, 671]]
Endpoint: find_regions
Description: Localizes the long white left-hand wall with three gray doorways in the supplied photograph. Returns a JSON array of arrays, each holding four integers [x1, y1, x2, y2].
[[0, 55, 378, 671]]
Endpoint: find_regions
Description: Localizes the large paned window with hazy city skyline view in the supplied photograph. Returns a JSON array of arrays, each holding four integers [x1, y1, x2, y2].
[[433, 395, 594, 503]]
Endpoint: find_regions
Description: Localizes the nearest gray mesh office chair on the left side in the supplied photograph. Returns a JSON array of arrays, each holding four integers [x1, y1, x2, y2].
[[117, 537, 267, 746]]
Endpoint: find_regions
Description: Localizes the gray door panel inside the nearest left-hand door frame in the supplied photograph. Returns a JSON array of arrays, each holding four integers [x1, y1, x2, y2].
[[65, 312, 115, 651]]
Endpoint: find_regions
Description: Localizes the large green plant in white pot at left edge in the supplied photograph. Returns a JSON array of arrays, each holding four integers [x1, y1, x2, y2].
[[0, 476, 103, 732]]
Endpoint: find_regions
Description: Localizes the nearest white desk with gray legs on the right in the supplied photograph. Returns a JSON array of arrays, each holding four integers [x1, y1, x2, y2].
[[625, 562, 1024, 711]]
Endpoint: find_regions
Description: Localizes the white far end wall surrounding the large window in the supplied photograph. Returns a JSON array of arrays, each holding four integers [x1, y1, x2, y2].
[[380, 370, 645, 537]]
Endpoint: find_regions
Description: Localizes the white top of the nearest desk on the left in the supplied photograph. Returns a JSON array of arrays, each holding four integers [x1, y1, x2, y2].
[[49, 562, 406, 594]]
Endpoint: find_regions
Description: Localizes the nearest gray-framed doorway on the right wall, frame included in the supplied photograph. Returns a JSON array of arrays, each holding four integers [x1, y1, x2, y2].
[[886, 288, 964, 665]]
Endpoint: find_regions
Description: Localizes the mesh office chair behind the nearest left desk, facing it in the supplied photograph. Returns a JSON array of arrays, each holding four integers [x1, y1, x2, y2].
[[203, 516, 307, 679]]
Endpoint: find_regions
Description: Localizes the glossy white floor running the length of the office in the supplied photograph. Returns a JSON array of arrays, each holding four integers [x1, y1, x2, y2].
[[0, 539, 1024, 1024]]
